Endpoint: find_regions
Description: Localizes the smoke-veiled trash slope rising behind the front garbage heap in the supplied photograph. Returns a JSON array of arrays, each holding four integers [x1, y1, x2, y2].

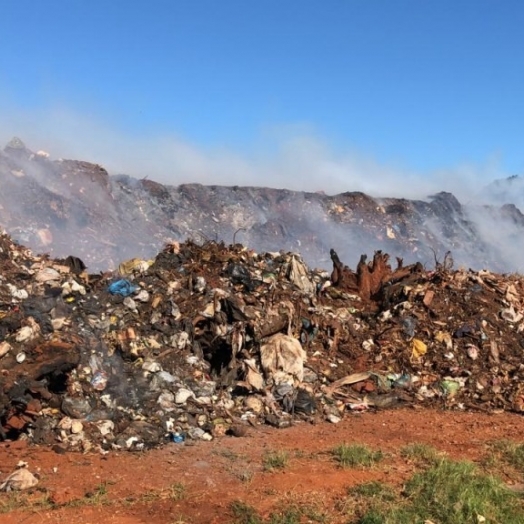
[[0, 139, 524, 271]]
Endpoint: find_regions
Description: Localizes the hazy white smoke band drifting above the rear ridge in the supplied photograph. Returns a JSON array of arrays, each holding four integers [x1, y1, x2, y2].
[[0, 103, 505, 202]]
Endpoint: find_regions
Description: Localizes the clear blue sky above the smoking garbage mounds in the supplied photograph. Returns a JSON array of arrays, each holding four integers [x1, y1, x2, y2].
[[0, 0, 524, 193]]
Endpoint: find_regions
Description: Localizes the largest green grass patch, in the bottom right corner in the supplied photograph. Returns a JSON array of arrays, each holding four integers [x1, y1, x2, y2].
[[352, 459, 524, 524]]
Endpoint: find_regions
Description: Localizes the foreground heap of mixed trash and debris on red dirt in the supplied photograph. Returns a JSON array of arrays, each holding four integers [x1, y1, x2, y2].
[[0, 228, 524, 452]]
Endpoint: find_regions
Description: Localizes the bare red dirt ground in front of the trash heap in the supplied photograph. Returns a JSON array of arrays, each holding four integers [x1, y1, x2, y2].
[[0, 408, 524, 524]]
